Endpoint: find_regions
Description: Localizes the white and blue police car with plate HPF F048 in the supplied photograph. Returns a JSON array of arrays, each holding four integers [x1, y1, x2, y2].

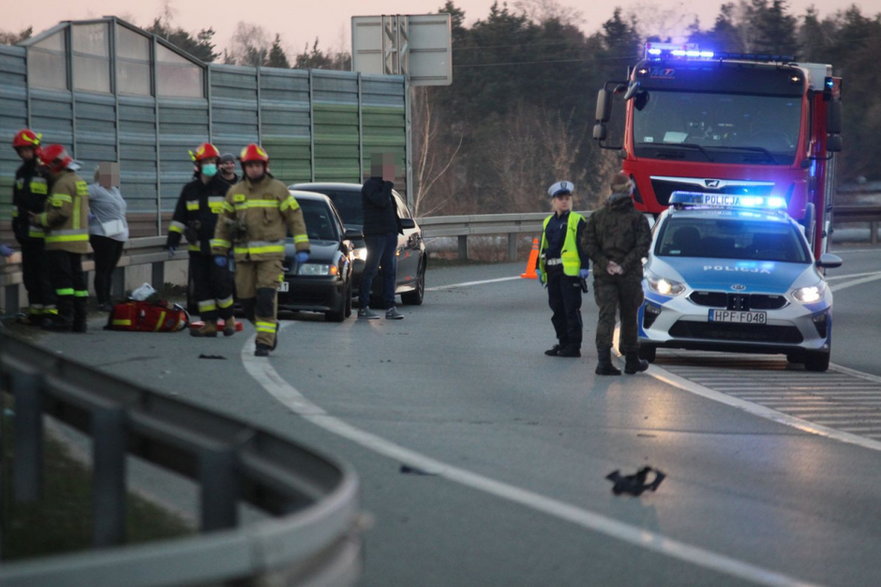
[[639, 192, 841, 371]]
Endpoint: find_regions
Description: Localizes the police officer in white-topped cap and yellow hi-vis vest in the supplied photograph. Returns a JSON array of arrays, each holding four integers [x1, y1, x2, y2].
[[535, 181, 590, 357]]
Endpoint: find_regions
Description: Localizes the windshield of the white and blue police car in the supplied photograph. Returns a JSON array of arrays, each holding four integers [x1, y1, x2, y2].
[[655, 212, 809, 263]]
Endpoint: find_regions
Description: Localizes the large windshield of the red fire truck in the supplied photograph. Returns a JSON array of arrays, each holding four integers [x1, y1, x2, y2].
[[633, 89, 802, 165]]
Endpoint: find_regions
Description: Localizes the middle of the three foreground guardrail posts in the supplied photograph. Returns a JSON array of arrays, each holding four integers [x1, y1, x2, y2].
[[92, 408, 128, 547]]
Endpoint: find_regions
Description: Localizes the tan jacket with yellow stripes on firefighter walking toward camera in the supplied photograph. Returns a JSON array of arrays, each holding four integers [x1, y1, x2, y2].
[[211, 174, 309, 261]]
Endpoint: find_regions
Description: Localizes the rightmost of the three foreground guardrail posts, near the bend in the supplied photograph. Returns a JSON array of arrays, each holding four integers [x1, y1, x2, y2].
[[199, 449, 239, 532]]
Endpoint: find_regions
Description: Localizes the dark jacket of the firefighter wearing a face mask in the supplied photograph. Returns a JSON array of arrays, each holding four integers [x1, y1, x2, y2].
[[165, 173, 229, 255]]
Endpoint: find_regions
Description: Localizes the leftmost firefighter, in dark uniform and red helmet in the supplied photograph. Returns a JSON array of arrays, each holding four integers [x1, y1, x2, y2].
[[12, 128, 58, 326]]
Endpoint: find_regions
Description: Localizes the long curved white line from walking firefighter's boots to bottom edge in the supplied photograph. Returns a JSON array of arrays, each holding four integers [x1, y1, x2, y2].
[[241, 330, 810, 586]]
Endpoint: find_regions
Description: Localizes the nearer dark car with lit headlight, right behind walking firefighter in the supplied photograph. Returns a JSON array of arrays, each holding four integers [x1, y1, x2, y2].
[[278, 190, 361, 322]]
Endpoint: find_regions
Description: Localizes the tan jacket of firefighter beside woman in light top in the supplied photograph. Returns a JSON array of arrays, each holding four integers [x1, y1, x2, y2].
[[38, 169, 90, 253]]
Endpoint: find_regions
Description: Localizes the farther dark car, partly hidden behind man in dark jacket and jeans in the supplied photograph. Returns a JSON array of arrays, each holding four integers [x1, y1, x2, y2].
[[289, 183, 428, 305]]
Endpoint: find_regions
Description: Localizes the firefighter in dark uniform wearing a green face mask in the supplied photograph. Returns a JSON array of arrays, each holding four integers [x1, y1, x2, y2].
[[165, 143, 236, 337]]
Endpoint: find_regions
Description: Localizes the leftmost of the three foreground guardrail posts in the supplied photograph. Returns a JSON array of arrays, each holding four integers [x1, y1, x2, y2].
[[11, 372, 43, 503]]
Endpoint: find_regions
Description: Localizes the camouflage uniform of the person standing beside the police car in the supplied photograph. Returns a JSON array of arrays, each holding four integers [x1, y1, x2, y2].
[[584, 193, 652, 353]]
